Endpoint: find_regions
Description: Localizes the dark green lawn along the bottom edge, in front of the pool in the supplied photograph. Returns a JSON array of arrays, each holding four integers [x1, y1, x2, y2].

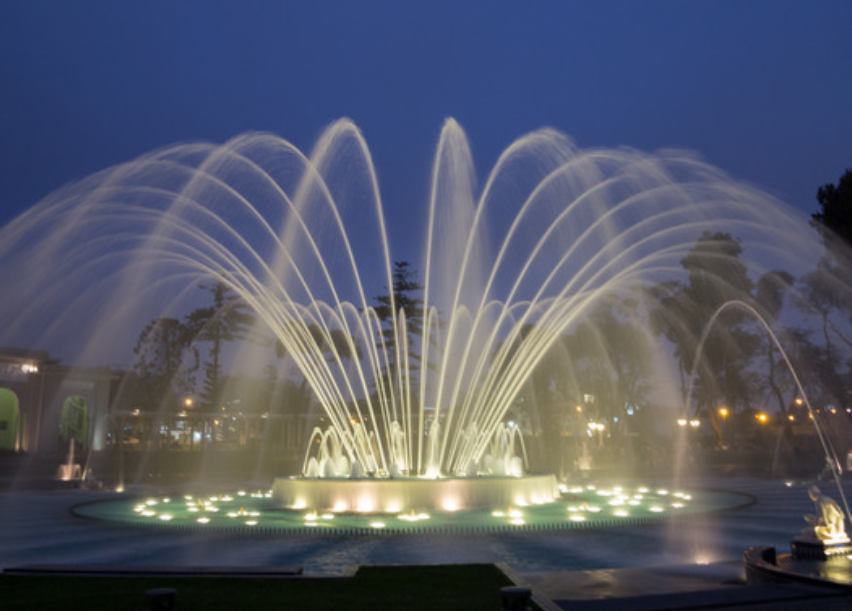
[[0, 564, 512, 611]]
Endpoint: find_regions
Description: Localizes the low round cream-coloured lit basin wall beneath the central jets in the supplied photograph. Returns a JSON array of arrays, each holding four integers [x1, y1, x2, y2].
[[272, 474, 559, 513]]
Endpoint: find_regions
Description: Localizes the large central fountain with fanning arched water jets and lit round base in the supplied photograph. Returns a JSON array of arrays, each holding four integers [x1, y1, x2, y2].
[[0, 120, 815, 511]]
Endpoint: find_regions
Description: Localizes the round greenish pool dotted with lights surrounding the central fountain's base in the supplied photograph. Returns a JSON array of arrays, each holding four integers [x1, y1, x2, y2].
[[72, 485, 752, 535]]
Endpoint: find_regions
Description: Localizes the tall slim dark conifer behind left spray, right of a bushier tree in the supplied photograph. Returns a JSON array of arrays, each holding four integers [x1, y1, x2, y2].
[[184, 280, 254, 411]]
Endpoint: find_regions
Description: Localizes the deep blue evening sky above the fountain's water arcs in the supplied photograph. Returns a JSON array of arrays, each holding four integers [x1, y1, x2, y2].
[[0, 0, 852, 258]]
